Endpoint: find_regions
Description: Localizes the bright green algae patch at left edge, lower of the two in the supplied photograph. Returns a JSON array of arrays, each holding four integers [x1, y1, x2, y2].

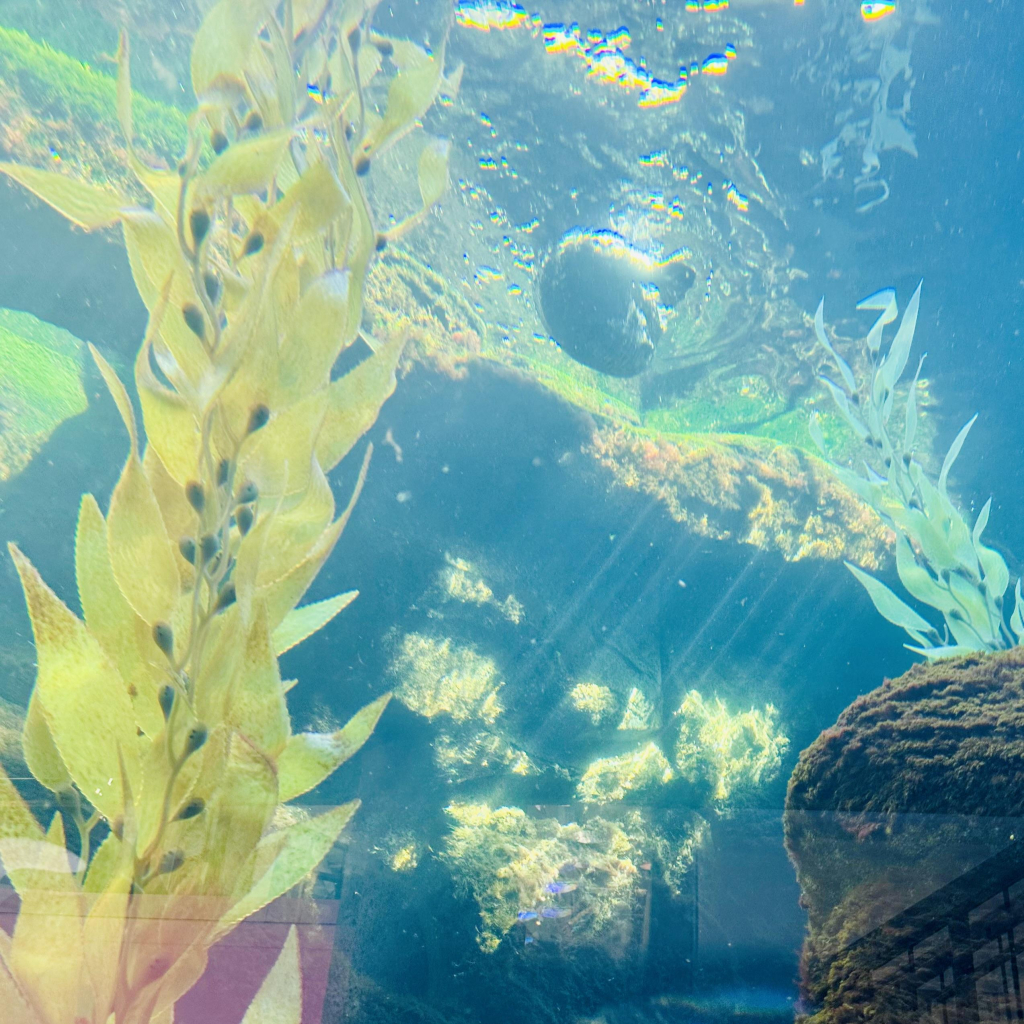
[[0, 308, 88, 480]]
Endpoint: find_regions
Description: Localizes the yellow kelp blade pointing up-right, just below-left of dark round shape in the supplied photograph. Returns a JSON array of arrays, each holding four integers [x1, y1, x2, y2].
[[316, 335, 406, 473]]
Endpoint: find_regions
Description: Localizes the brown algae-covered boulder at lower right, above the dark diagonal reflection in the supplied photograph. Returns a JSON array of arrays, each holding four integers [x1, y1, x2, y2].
[[785, 647, 1024, 1024]]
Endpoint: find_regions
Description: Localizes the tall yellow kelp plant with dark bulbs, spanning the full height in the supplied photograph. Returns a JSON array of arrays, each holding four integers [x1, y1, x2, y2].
[[0, 0, 446, 1024]]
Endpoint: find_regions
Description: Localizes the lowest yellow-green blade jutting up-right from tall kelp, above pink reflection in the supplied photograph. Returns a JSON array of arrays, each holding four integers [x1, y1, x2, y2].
[[215, 800, 359, 938]]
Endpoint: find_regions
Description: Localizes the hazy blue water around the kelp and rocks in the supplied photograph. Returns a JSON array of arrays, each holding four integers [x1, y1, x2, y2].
[[0, 0, 1024, 1024]]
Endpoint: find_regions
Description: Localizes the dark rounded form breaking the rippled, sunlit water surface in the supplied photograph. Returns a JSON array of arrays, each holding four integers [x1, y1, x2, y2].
[[538, 230, 694, 377]]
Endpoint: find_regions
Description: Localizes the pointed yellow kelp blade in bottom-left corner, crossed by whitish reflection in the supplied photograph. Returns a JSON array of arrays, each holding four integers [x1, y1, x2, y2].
[[9, 814, 89, 1022]]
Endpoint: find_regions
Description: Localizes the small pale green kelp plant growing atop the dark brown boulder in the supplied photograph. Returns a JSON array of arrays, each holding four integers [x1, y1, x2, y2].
[[810, 285, 1024, 659]]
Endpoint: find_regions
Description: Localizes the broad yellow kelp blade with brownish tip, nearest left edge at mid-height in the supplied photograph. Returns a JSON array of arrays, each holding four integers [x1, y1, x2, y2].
[[8, 544, 138, 821]]
